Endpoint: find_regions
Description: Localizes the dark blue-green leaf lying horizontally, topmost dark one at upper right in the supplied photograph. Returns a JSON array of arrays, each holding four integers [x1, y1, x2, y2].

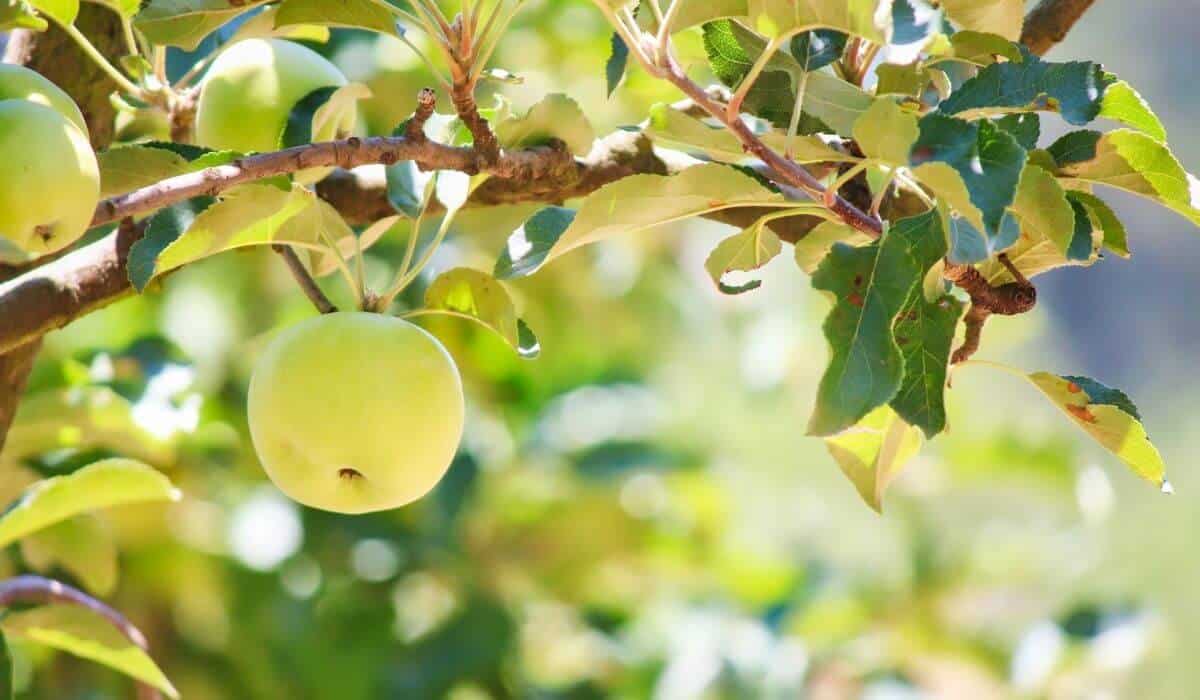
[[937, 48, 1115, 125]]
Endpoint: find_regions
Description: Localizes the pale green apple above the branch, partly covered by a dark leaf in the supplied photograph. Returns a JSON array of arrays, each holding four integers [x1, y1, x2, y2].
[[196, 38, 356, 181]]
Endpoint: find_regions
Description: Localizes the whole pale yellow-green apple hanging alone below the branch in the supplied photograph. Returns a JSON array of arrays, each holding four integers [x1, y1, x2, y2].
[[247, 312, 464, 513]]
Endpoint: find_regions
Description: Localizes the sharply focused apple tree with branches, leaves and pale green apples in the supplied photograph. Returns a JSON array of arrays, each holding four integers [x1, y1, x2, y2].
[[0, 0, 1200, 696]]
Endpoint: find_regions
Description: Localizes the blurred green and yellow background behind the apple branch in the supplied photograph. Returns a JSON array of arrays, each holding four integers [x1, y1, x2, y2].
[[0, 0, 1200, 700]]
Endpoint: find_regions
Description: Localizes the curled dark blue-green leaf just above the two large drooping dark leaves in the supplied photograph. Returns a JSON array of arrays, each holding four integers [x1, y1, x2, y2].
[[910, 113, 1026, 241]]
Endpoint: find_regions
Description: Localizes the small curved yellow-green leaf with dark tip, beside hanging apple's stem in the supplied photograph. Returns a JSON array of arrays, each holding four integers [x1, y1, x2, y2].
[[425, 268, 538, 358]]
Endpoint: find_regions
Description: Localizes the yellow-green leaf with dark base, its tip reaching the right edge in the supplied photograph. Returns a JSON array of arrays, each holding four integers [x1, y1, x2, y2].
[[1049, 128, 1200, 226]]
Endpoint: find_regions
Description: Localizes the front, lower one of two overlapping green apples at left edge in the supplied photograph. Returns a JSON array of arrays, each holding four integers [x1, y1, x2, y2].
[[0, 100, 100, 261]]
